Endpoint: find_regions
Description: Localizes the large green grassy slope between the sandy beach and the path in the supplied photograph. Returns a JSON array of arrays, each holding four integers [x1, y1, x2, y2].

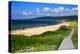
[[11, 26, 71, 53]]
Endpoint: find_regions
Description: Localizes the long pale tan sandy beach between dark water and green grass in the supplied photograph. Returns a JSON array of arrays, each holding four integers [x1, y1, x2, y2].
[[11, 22, 69, 36]]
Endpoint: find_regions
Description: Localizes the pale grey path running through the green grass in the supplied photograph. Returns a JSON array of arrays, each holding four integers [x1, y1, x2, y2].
[[59, 30, 74, 50]]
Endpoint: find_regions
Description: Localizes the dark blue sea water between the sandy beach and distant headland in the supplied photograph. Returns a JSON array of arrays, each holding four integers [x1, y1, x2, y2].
[[11, 20, 60, 30]]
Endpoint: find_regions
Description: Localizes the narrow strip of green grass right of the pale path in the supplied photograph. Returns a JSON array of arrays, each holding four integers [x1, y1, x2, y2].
[[72, 20, 78, 49]]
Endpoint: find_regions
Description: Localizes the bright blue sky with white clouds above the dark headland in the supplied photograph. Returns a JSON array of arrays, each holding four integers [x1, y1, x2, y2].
[[10, 1, 78, 19]]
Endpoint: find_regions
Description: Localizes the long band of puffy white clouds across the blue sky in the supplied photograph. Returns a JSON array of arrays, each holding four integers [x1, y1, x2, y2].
[[22, 6, 78, 16]]
